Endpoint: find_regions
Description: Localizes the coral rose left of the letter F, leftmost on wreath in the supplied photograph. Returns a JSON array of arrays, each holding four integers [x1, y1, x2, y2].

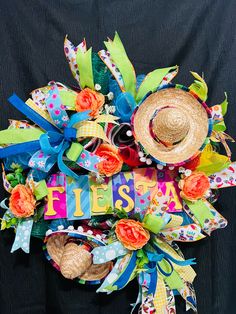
[[9, 184, 36, 218]]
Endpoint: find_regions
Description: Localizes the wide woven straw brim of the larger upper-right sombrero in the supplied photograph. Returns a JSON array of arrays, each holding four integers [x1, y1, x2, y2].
[[133, 88, 209, 164]]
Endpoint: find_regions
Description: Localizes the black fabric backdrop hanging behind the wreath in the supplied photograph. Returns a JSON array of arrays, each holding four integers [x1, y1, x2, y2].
[[0, 0, 236, 314]]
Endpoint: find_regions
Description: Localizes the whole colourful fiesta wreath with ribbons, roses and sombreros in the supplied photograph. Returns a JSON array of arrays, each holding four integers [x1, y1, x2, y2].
[[0, 34, 236, 314]]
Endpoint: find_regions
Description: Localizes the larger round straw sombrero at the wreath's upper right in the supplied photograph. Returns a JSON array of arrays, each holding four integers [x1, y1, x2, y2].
[[132, 85, 212, 165]]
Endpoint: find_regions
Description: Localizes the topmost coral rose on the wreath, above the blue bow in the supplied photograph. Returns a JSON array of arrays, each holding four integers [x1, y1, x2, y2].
[[75, 88, 105, 118]]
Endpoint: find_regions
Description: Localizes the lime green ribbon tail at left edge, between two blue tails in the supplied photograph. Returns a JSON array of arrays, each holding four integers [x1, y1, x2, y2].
[[0, 128, 44, 145]]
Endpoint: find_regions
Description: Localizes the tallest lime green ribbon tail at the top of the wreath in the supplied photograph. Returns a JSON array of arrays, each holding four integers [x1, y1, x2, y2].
[[104, 32, 136, 97]]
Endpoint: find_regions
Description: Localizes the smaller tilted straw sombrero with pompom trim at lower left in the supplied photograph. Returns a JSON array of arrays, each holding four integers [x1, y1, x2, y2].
[[44, 226, 113, 284]]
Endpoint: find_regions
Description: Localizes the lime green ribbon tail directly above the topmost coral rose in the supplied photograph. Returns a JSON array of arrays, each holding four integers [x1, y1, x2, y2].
[[76, 48, 94, 89]]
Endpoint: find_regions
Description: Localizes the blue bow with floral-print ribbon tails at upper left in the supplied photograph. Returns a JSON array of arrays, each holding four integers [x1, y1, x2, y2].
[[0, 86, 100, 179]]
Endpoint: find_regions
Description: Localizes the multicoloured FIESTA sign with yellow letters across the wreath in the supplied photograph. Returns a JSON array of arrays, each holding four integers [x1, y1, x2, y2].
[[44, 168, 182, 220]]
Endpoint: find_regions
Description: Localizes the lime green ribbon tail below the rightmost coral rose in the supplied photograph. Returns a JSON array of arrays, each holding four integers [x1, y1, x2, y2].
[[185, 200, 214, 227]]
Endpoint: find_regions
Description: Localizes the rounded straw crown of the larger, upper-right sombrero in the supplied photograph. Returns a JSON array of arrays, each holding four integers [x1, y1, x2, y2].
[[152, 107, 190, 144]]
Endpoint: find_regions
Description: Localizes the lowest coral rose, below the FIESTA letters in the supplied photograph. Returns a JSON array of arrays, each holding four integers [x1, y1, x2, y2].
[[115, 219, 150, 250]]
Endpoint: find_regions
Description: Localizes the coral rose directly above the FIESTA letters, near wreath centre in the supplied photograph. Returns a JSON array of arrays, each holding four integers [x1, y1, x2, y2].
[[96, 144, 123, 177]]
